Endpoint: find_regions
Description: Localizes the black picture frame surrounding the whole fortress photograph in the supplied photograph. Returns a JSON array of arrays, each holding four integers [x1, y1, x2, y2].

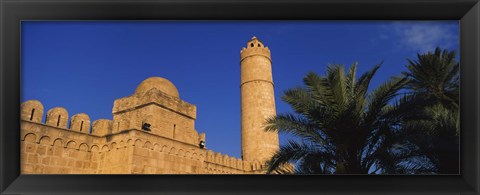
[[0, 0, 480, 194]]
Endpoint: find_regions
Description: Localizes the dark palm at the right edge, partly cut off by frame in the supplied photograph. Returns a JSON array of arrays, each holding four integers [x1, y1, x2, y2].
[[403, 48, 460, 174]]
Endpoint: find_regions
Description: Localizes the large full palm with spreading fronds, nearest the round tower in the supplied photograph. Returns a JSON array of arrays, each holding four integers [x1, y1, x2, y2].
[[265, 64, 407, 174]]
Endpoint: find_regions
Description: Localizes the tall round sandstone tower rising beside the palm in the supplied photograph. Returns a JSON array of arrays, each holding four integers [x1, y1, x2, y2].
[[240, 37, 279, 163]]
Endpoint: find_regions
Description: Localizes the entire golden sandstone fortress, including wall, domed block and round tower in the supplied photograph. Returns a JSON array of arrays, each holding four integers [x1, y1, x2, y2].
[[20, 37, 278, 174]]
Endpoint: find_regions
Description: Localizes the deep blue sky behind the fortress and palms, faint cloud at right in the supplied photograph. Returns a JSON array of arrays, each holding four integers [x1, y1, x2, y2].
[[21, 21, 459, 157]]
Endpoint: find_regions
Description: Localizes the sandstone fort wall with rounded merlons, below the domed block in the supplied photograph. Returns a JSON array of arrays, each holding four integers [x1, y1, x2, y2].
[[20, 100, 263, 174]]
